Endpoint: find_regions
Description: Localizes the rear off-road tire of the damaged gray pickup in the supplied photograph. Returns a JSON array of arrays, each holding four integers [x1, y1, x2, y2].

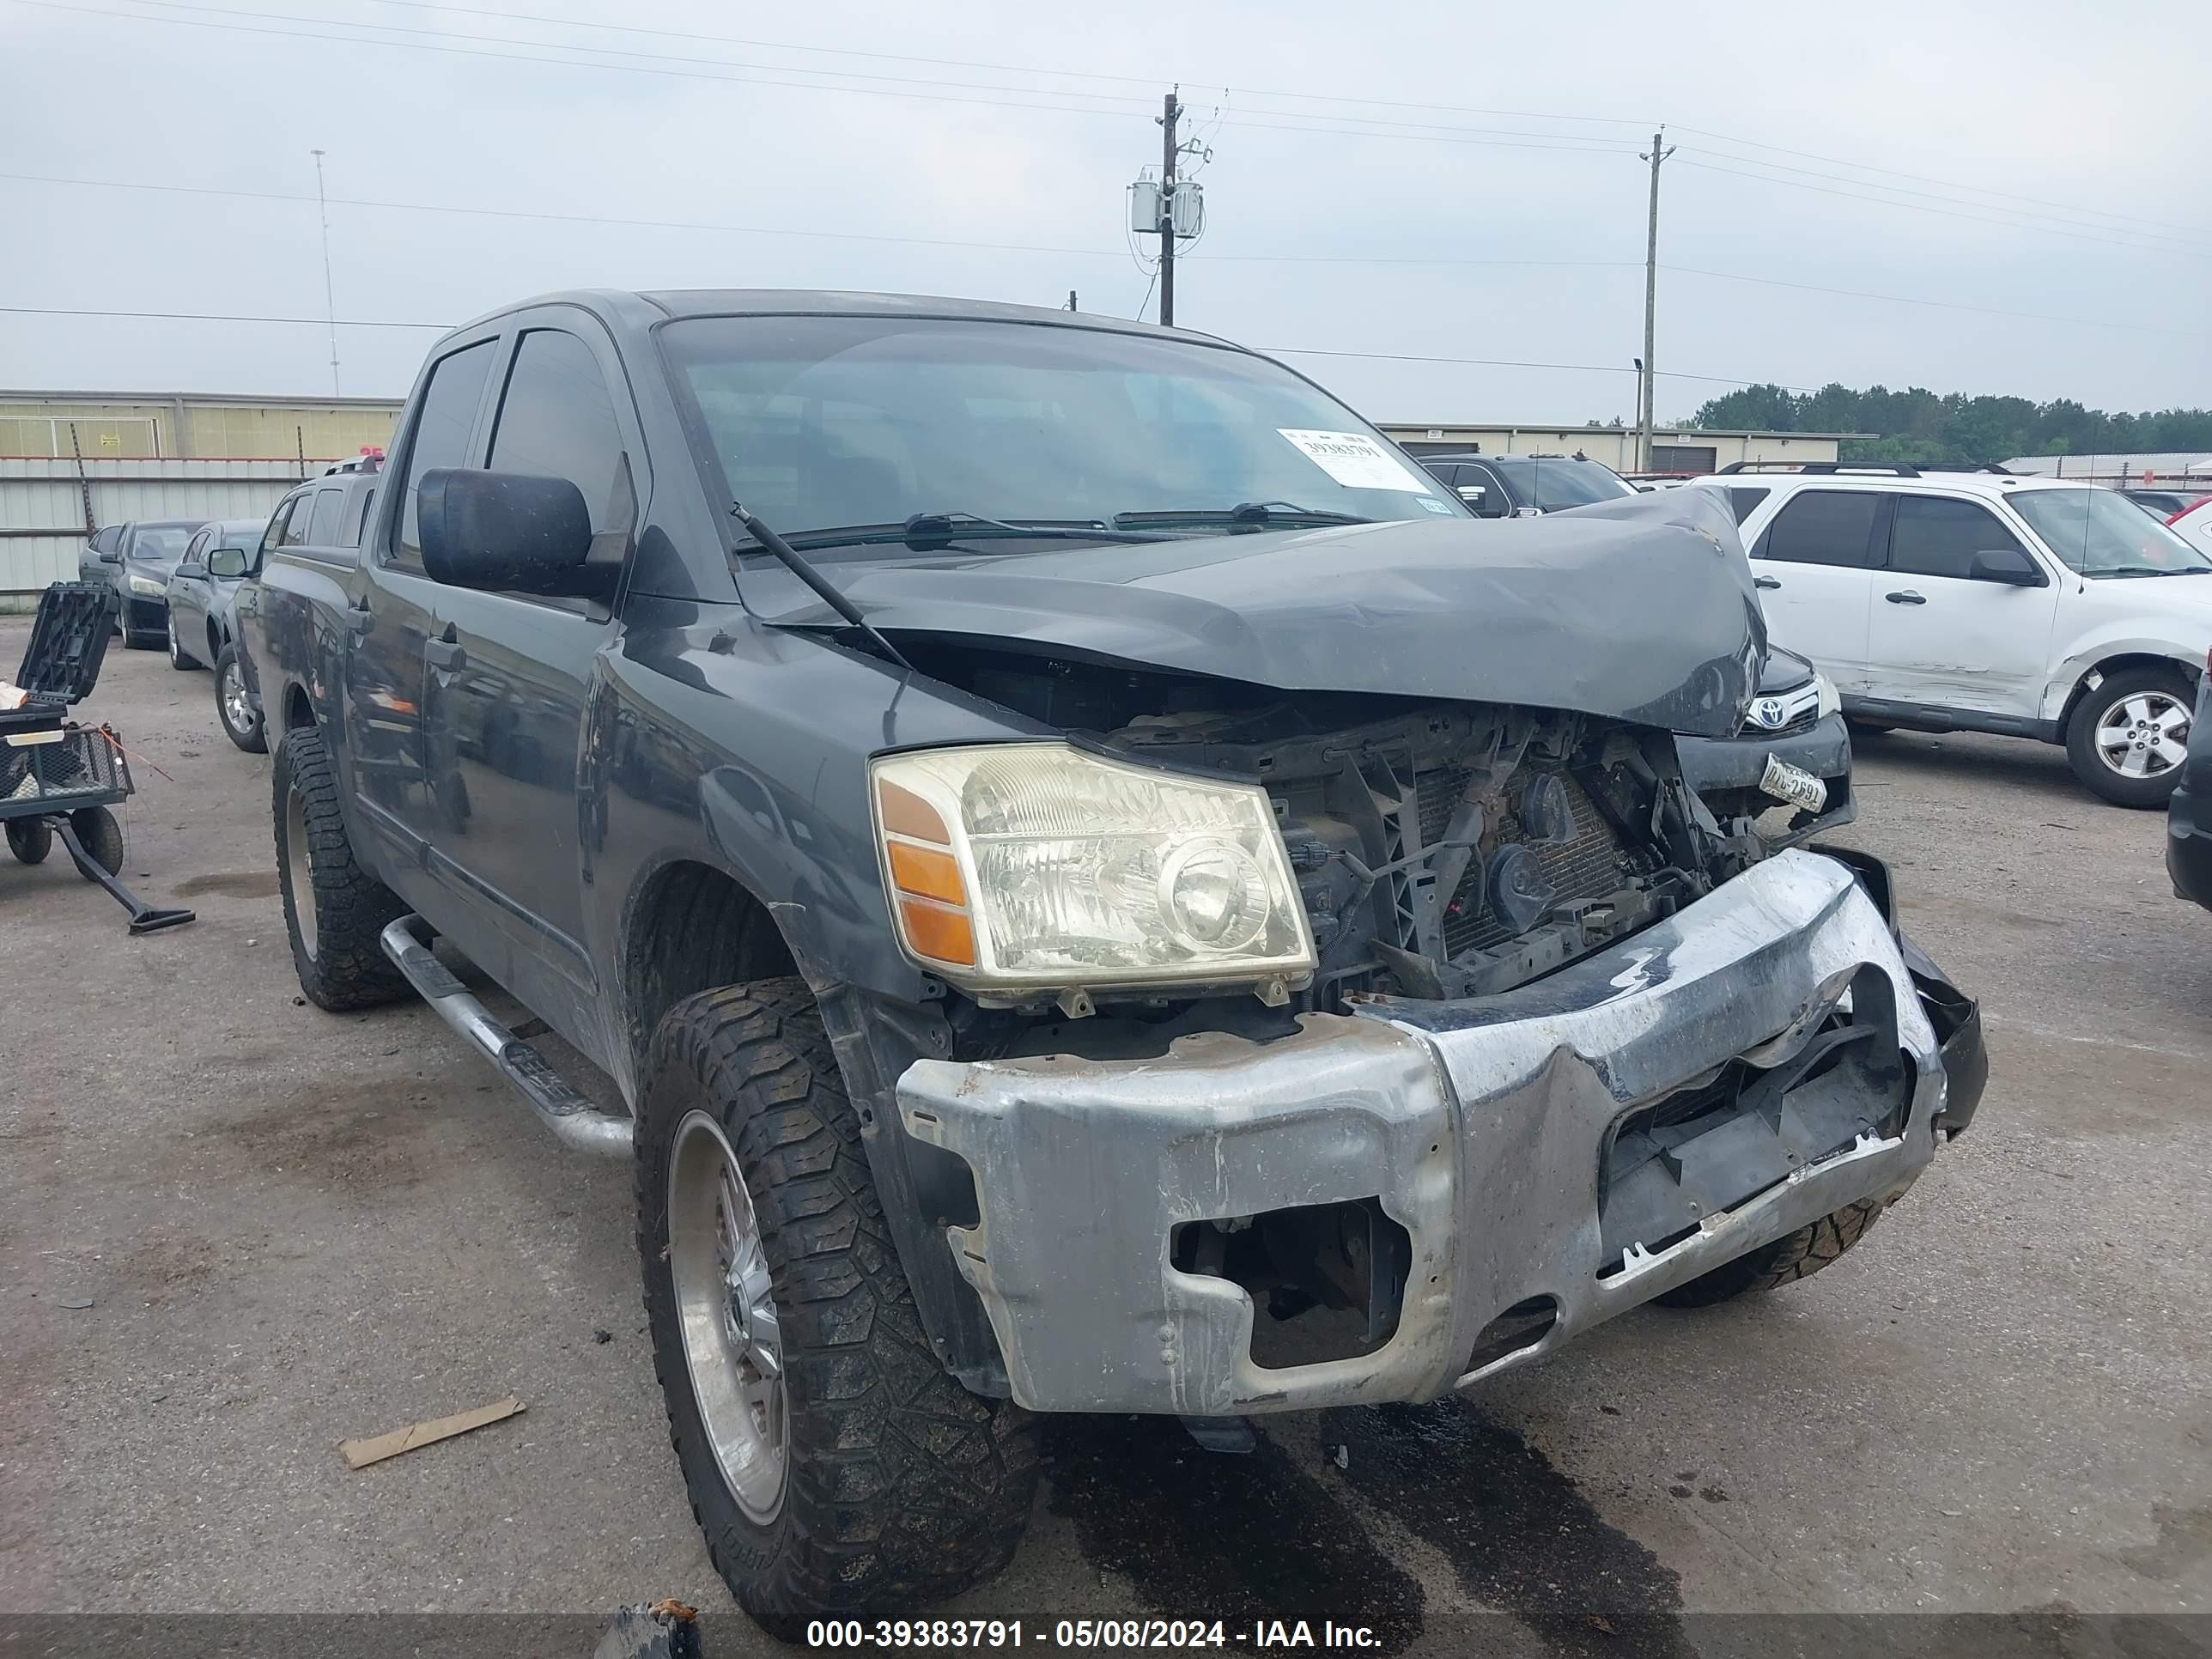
[[270, 726, 407, 1013]]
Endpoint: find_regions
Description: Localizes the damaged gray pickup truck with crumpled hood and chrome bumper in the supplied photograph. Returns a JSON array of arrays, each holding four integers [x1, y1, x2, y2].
[[250, 292, 1986, 1637]]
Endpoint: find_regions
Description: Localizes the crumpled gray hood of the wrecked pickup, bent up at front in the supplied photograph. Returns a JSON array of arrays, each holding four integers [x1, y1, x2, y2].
[[744, 489, 1765, 737]]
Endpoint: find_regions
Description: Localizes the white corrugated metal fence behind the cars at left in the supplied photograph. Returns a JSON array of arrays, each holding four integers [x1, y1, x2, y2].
[[0, 456, 330, 608]]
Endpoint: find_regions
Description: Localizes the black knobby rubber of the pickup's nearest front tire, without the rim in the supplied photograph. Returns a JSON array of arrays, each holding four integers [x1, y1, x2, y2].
[[637, 978, 1037, 1641]]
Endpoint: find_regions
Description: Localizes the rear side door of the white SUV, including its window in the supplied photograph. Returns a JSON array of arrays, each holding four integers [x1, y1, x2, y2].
[[1750, 489, 1882, 696]]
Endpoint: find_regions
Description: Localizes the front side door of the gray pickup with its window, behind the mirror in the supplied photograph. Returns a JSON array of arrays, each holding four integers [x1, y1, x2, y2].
[[425, 318, 644, 1009]]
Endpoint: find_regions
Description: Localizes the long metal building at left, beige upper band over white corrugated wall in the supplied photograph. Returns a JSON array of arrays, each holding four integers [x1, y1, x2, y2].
[[0, 392, 400, 611]]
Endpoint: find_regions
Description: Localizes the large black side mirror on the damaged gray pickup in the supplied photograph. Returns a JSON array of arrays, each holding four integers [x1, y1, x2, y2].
[[416, 467, 611, 598]]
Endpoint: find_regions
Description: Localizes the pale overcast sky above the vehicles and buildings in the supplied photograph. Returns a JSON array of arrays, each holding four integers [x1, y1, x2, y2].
[[0, 0, 2212, 420]]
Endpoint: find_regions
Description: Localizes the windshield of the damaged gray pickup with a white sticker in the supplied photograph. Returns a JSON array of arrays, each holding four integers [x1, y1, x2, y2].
[[661, 316, 1464, 556]]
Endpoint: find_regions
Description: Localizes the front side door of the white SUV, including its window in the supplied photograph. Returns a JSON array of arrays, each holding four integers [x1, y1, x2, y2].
[[1867, 491, 2059, 719]]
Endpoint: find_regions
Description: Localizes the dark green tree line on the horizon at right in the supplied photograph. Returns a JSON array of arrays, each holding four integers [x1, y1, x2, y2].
[[1690, 385, 2212, 462]]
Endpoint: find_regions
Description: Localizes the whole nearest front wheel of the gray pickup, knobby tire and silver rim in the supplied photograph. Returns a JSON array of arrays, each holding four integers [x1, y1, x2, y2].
[[637, 980, 1037, 1641]]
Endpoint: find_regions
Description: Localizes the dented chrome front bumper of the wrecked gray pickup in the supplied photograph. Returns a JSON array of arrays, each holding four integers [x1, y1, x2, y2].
[[896, 852, 1980, 1416]]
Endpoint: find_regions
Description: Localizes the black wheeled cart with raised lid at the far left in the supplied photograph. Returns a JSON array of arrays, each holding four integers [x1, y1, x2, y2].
[[0, 581, 192, 933]]
